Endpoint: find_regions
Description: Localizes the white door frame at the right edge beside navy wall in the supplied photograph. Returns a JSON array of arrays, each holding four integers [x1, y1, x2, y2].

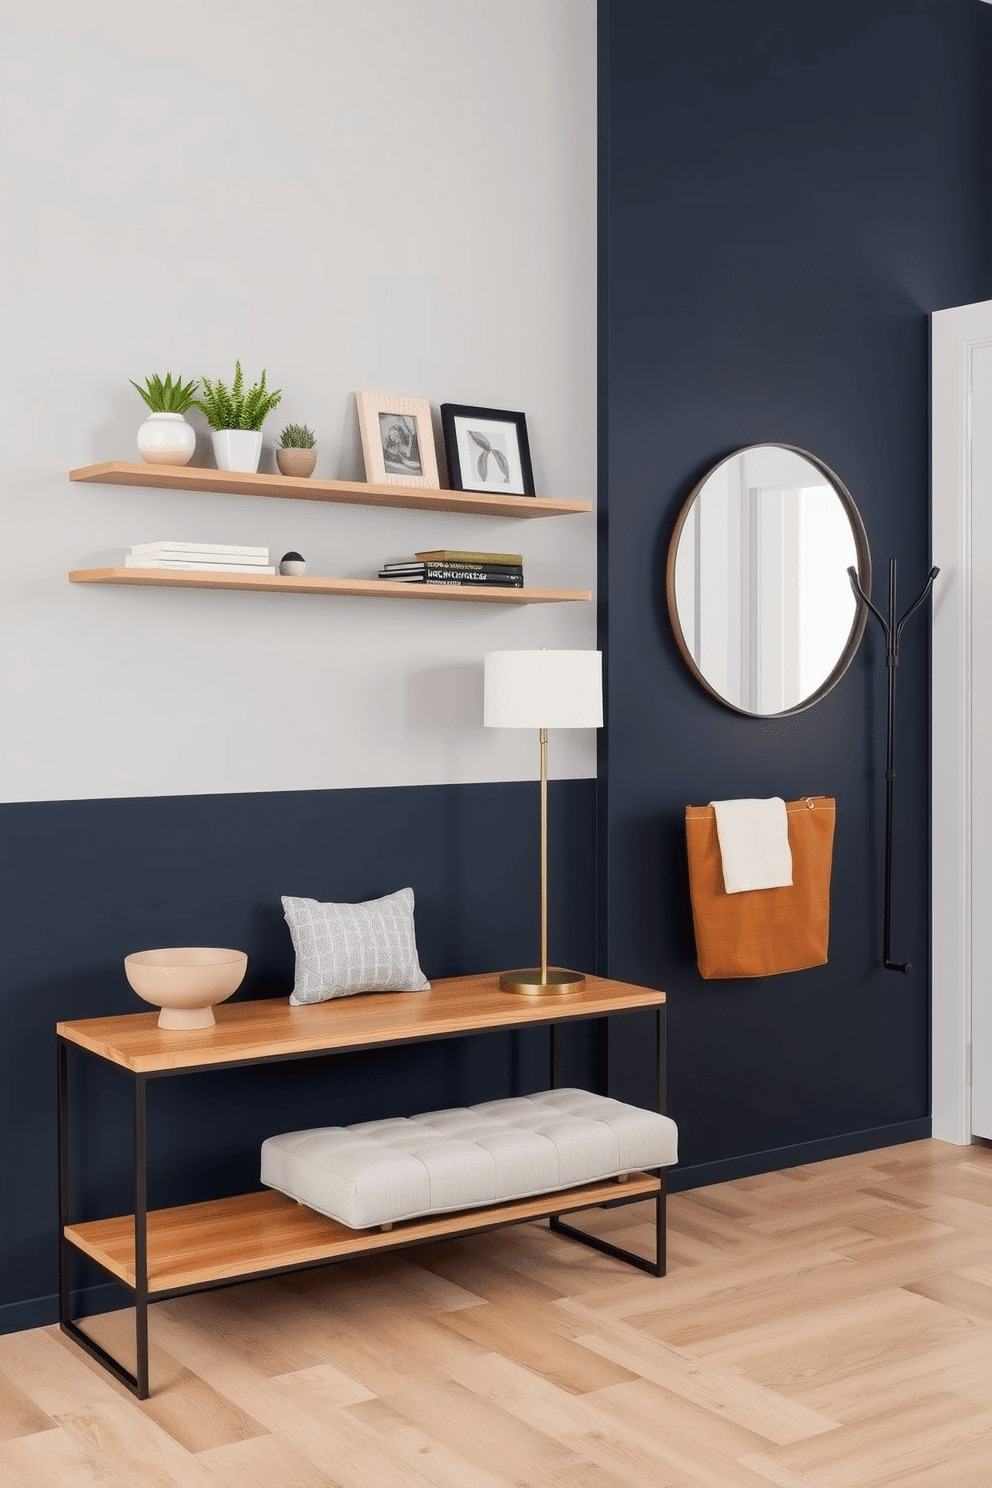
[[931, 301, 992, 1144]]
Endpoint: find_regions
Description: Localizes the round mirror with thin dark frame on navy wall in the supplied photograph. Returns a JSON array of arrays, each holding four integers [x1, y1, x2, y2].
[[666, 445, 872, 717]]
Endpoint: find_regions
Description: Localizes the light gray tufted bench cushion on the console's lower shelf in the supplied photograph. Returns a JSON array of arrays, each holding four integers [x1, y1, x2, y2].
[[262, 1089, 678, 1229]]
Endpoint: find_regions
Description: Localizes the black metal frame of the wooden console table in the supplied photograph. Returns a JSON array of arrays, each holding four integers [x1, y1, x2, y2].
[[57, 1003, 666, 1400]]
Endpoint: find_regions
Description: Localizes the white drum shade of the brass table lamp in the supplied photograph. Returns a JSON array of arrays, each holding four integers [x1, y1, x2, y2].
[[483, 650, 602, 729]]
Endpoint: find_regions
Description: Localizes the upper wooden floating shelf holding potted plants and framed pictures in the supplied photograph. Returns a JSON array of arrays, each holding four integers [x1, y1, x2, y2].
[[68, 460, 592, 516]]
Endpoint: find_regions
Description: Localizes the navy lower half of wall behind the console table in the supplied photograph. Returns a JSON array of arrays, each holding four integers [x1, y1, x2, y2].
[[0, 780, 596, 1332]]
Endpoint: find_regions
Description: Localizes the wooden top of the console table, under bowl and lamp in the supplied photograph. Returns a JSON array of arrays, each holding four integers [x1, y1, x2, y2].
[[57, 972, 665, 1074]]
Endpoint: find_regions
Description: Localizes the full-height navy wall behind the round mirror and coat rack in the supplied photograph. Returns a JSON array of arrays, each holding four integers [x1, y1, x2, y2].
[[599, 0, 992, 1184]]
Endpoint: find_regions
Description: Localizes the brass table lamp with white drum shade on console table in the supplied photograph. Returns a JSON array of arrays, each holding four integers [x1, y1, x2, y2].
[[483, 650, 602, 997]]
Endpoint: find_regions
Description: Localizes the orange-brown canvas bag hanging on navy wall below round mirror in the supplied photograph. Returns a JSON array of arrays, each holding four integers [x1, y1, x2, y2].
[[686, 796, 837, 979]]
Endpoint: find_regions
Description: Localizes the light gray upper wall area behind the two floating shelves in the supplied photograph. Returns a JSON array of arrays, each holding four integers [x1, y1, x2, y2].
[[0, 0, 596, 801]]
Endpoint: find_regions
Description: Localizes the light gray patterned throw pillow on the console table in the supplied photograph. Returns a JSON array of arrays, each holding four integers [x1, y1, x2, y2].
[[283, 888, 430, 1007]]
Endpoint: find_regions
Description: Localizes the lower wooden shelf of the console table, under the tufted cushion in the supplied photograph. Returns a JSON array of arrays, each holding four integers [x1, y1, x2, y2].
[[65, 1173, 662, 1298]]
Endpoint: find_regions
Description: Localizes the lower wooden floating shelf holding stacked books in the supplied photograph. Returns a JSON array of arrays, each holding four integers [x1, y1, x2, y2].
[[68, 567, 592, 604]]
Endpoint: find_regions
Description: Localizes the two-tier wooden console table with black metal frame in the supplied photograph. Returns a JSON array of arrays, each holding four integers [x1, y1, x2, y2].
[[57, 973, 665, 1400]]
